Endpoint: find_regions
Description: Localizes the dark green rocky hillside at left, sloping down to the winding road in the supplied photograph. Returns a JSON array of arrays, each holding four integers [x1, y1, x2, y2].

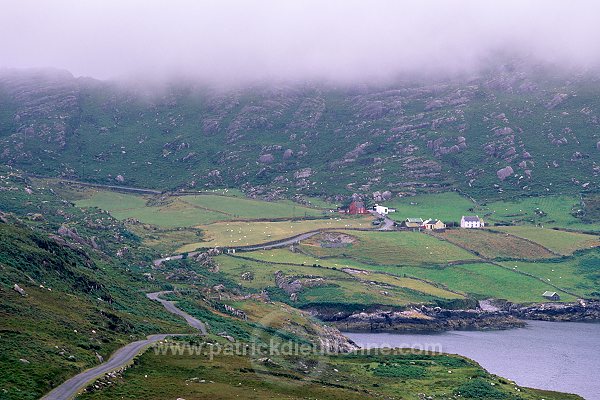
[[0, 168, 187, 399]]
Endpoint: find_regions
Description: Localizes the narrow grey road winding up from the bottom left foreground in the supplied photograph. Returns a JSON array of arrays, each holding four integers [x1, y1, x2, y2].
[[42, 291, 206, 400]]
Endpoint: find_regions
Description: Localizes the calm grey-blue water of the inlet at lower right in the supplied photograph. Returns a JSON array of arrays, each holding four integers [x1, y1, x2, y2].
[[346, 321, 600, 400]]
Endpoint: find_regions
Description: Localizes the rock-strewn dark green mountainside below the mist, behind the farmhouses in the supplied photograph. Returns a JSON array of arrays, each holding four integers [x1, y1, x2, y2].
[[0, 63, 600, 203]]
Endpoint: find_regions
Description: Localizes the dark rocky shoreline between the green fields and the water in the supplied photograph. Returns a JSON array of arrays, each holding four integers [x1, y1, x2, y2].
[[310, 300, 600, 332]]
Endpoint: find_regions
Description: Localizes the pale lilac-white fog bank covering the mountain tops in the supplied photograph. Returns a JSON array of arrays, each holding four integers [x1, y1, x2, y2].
[[0, 0, 600, 83]]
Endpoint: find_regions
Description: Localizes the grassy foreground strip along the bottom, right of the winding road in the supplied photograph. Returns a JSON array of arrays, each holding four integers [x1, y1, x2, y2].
[[81, 351, 579, 400]]
